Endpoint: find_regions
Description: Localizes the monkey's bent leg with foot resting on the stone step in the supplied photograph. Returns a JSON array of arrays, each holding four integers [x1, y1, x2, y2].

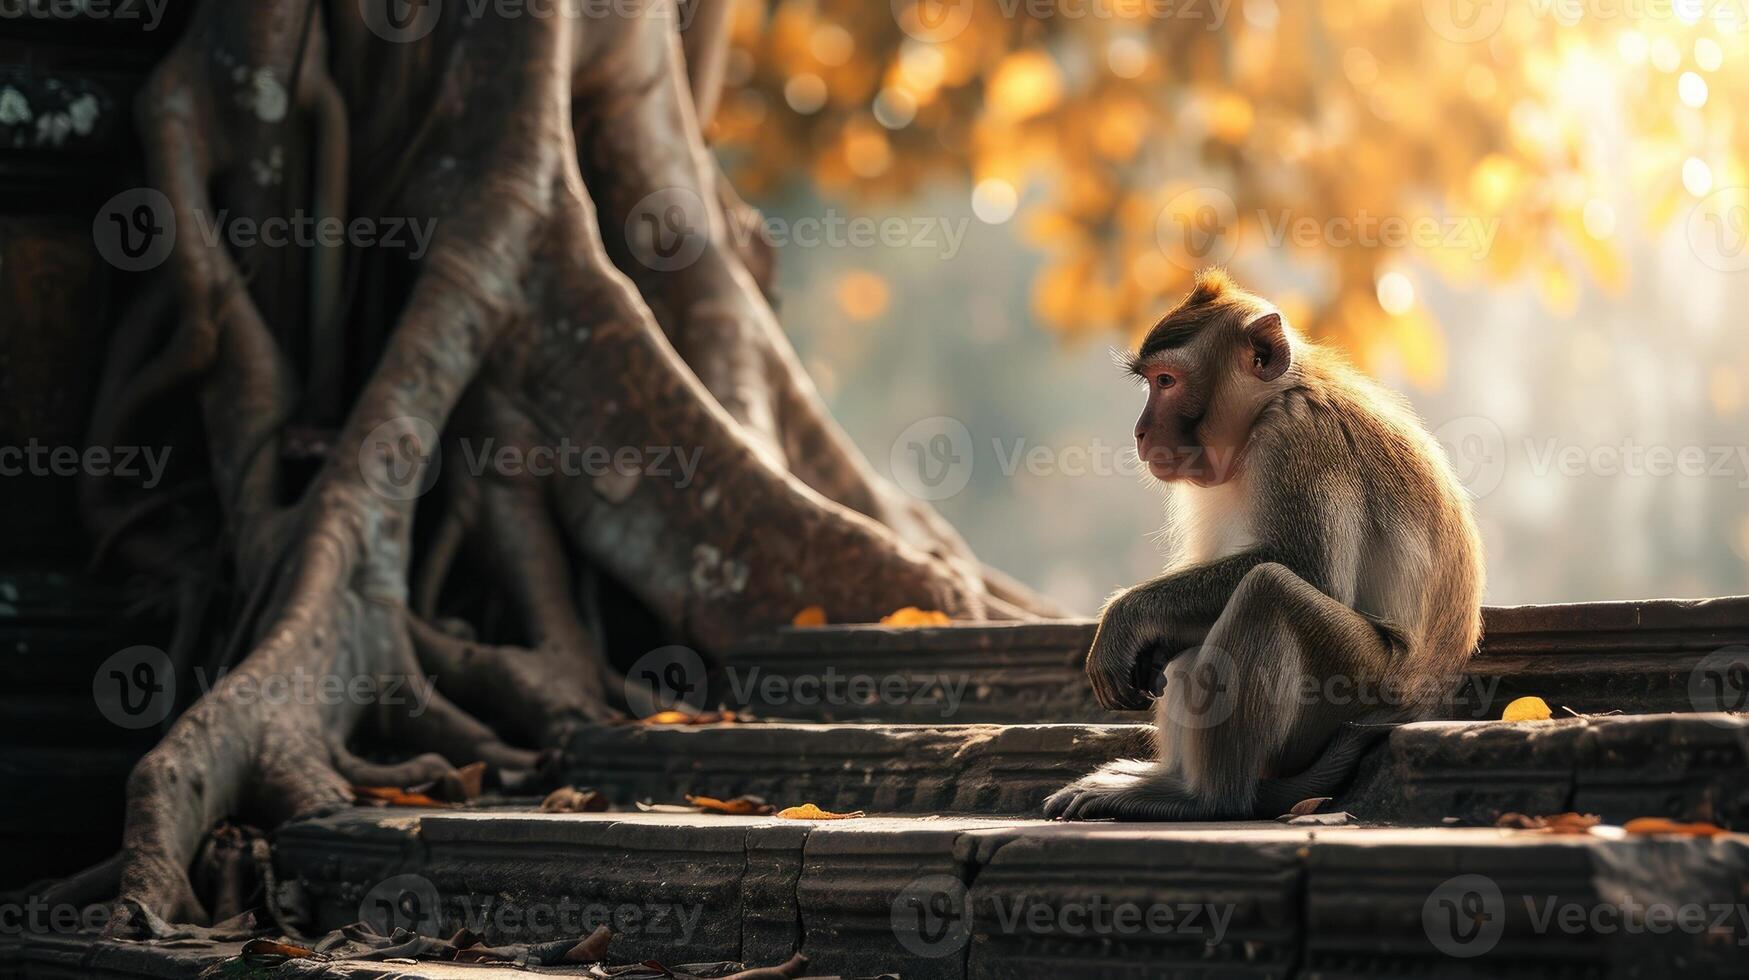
[[1044, 564, 1392, 821]]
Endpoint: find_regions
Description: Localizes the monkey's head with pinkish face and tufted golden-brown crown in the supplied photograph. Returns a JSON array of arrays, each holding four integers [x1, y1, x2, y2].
[[1126, 270, 1294, 487]]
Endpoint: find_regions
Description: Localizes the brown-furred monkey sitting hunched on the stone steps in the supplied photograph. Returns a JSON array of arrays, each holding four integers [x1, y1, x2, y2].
[[1044, 270, 1483, 821]]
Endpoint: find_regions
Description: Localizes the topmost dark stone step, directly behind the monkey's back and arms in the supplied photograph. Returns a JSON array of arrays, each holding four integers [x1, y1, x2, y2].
[[708, 597, 1749, 725]]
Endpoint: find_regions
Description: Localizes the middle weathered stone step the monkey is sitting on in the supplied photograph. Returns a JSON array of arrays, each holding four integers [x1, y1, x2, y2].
[[549, 714, 1749, 826]]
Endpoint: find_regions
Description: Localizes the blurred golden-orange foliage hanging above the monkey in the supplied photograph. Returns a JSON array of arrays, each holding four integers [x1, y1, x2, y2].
[[712, 0, 1721, 374]]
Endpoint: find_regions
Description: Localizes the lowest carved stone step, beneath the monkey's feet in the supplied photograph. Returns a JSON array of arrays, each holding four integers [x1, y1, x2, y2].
[[253, 810, 1749, 980]]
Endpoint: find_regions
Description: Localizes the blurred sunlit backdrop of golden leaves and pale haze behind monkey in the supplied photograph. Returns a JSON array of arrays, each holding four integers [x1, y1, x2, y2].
[[712, 0, 1749, 613]]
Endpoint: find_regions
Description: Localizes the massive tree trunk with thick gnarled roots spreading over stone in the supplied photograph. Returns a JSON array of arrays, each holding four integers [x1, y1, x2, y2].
[[84, 0, 1053, 922]]
